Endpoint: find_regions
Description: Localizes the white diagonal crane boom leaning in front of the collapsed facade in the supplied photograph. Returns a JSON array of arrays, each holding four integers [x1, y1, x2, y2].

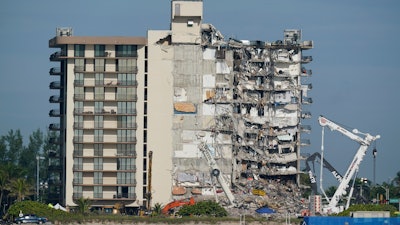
[[198, 142, 236, 206]]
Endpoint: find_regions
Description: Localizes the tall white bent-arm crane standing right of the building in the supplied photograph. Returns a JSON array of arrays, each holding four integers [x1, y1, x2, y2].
[[318, 116, 380, 214]]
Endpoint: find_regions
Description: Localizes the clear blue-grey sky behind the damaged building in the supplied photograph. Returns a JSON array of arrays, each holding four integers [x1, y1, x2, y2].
[[0, 0, 400, 186]]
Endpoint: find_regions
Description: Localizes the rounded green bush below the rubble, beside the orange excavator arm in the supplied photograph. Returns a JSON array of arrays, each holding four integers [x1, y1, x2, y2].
[[178, 201, 228, 217]]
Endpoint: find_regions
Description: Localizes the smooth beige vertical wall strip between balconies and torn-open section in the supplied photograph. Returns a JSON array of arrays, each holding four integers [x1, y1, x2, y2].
[[147, 31, 173, 205]]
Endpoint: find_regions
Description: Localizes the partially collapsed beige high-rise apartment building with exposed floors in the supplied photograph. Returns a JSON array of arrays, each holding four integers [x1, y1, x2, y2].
[[49, 0, 313, 214]]
